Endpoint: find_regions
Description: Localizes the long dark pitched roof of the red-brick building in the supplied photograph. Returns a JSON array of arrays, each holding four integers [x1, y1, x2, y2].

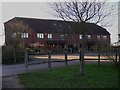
[[6, 17, 110, 35]]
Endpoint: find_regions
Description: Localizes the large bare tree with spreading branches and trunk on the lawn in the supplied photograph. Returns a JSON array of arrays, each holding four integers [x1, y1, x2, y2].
[[50, 0, 113, 75]]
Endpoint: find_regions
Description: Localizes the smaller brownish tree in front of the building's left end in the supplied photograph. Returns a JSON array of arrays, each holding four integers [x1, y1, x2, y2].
[[5, 19, 31, 63]]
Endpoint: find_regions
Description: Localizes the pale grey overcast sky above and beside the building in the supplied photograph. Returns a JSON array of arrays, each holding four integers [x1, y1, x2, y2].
[[0, 2, 118, 44]]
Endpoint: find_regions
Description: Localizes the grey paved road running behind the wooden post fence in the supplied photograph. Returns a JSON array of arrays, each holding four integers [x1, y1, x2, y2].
[[2, 60, 111, 77]]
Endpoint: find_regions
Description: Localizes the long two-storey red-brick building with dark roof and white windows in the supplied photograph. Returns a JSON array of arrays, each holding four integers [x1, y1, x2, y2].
[[4, 17, 110, 52]]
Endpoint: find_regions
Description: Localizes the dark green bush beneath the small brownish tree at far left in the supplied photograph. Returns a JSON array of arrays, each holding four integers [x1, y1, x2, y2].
[[2, 46, 24, 65]]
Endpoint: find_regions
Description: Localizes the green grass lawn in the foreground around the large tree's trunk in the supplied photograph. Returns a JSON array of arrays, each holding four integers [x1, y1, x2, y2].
[[19, 64, 118, 88]]
